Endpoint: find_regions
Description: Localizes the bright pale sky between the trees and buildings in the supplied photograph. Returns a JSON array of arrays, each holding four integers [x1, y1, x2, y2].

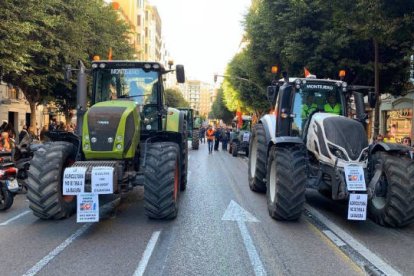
[[149, 0, 251, 82]]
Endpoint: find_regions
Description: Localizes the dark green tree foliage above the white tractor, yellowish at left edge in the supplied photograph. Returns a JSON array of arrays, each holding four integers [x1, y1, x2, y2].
[[223, 0, 414, 104]]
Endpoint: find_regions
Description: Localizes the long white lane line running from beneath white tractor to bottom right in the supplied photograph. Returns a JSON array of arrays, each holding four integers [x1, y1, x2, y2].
[[305, 204, 401, 276]]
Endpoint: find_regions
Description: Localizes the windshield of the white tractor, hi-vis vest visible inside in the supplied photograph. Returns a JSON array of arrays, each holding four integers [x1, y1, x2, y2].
[[292, 81, 344, 136]]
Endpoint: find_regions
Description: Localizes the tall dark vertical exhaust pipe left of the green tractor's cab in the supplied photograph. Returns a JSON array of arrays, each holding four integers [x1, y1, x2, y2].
[[76, 60, 87, 136]]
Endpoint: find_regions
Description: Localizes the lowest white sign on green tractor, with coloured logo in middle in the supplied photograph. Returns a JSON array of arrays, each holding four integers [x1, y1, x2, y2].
[[76, 193, 99, 222]]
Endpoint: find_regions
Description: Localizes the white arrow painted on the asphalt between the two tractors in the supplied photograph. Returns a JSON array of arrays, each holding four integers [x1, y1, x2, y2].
[[221, 200, 267, 276]]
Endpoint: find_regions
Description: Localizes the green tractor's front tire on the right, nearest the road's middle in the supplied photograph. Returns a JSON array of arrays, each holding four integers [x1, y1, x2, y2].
[[144, 142, 181, 219]]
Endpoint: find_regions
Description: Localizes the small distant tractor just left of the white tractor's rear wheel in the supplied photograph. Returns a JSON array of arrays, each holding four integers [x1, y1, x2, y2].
[[229, 115, 252, 157]]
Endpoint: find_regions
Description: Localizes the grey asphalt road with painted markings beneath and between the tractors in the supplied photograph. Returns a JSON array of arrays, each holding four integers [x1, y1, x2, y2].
[[0, 144, 414, 275]]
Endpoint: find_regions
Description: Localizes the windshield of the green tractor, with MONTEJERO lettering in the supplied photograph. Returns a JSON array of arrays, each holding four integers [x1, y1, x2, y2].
[[94, 68, 159, 105]]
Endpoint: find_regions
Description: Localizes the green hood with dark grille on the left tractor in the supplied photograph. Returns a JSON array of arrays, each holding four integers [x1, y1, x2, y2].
[[82, 100, 140, 159]]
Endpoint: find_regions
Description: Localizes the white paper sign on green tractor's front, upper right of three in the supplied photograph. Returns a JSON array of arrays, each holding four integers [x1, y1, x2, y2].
[[91, 167, 114, 194]]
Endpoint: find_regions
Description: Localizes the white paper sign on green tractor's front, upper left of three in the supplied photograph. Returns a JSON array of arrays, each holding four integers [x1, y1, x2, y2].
[[63, 167, 86, 195]]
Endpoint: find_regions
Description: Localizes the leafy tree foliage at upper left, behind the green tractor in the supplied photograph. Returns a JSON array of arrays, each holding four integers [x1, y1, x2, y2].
[[0, 0, 132, 127]]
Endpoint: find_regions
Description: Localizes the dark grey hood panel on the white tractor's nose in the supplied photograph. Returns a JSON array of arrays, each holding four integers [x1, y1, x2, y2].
[[323, 116, 368, 160]]
